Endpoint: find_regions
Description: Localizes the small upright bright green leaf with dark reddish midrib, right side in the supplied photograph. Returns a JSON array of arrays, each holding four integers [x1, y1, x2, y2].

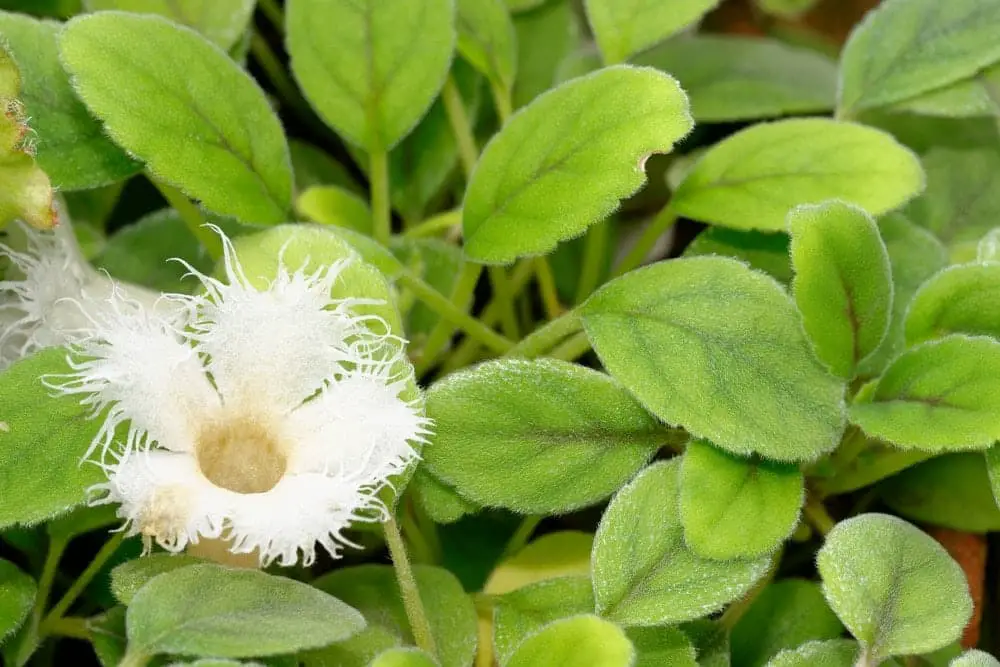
[[788, 202, 892, 380]]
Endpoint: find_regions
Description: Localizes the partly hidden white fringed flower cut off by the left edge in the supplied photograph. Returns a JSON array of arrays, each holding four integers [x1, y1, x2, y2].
[[0, 215, 159, 370]]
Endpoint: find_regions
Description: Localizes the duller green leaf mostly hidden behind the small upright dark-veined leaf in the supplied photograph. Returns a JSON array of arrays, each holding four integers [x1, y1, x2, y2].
[[858, 213, 948, 377]]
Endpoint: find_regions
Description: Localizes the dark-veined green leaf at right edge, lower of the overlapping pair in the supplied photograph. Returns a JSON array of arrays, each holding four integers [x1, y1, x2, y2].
[[850, 334, 1000, 452]]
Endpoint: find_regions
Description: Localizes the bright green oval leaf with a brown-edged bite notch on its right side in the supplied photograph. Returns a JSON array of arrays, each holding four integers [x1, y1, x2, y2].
[[462, 67, 692, 264]]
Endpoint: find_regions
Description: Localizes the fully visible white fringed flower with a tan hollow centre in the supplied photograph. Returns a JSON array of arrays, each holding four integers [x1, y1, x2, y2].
[[55, 230, 428, 565]]
